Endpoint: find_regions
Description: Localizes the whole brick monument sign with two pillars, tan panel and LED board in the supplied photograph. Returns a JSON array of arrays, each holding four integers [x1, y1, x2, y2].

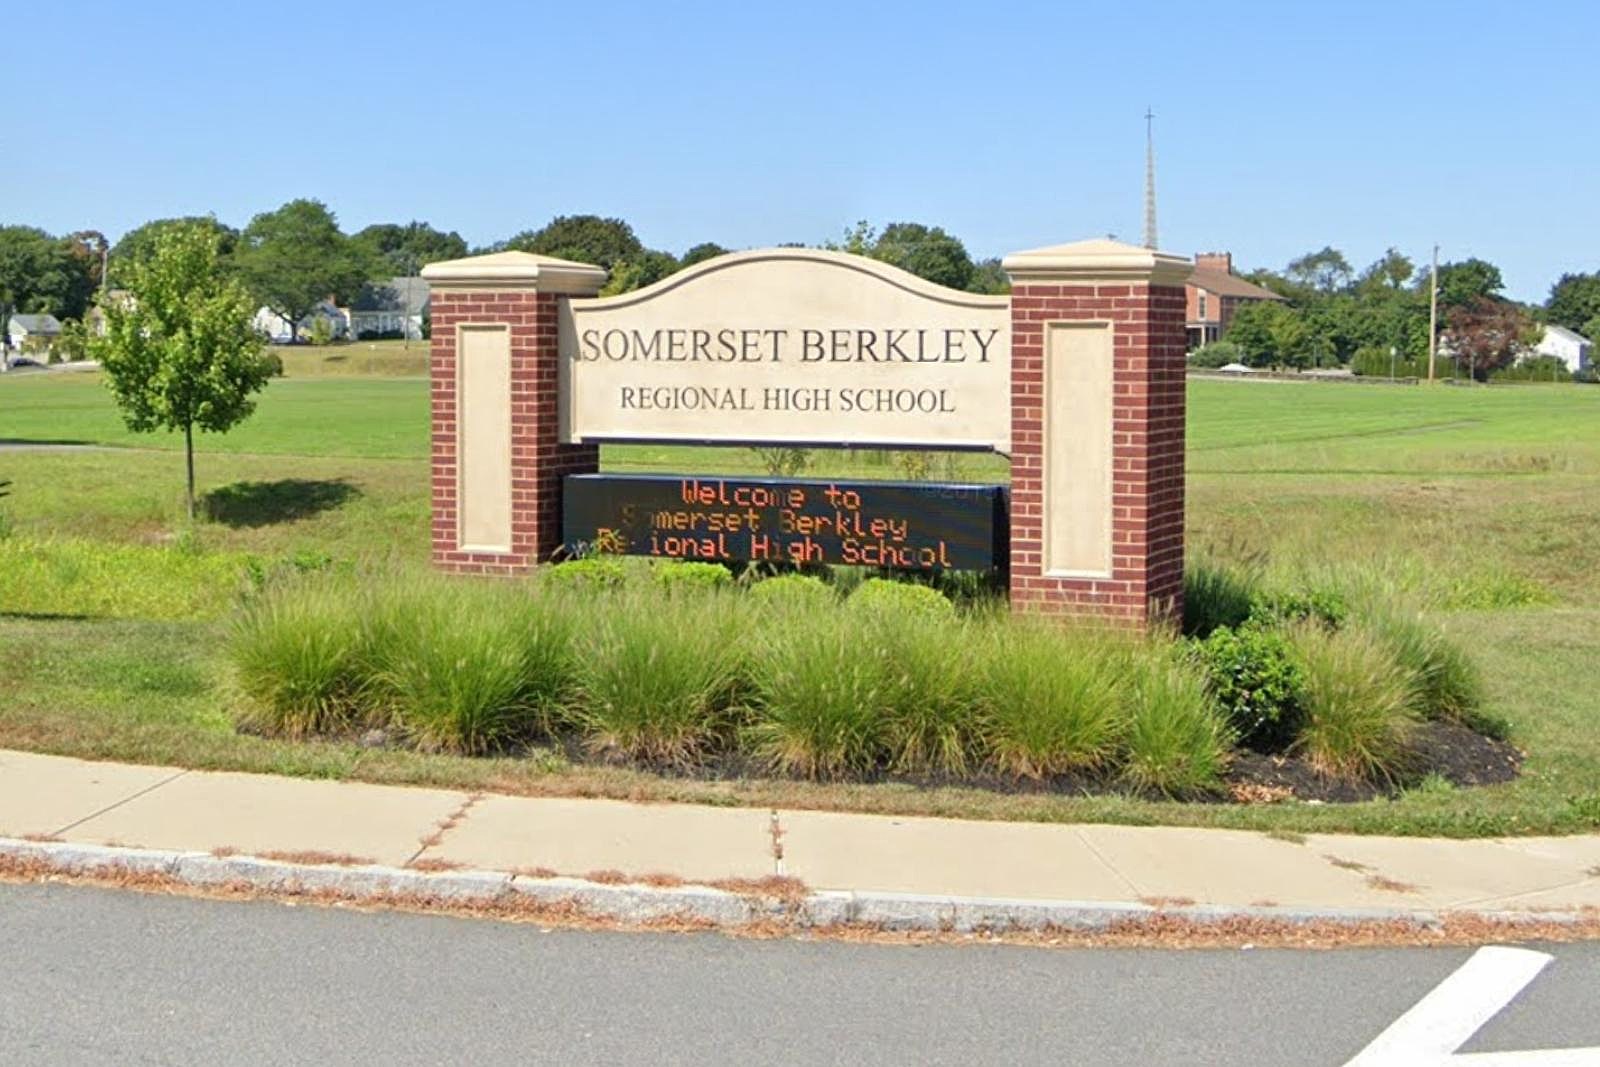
[[422, 240, 1189, 624]]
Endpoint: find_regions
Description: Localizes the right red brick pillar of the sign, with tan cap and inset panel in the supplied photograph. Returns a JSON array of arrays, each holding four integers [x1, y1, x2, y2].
[[1005, 240, 1190, 625]]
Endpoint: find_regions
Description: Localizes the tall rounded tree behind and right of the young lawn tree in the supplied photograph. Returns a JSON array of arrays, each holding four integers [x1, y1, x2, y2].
[[234, 200, 379, 336]]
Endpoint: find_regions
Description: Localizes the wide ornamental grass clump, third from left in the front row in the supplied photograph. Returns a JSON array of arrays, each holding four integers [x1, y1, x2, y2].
[[576, 595, 741, 766]]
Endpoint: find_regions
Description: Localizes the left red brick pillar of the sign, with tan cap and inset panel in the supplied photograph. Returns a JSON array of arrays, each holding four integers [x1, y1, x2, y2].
[[422, 251, 605, 574]]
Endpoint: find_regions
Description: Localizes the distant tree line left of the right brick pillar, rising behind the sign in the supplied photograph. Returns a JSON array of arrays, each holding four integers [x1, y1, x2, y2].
[[0, 200, 1005, 343]]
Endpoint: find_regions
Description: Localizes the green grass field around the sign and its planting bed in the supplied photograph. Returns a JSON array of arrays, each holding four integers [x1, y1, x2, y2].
[[0, 371, 1600, 833]]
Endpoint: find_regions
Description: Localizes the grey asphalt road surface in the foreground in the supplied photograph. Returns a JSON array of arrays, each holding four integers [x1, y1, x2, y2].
[[0, 885, 1600, 1067]]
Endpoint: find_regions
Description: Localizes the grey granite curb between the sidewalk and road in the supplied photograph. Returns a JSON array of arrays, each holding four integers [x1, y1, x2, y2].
[[0, 838, 1595, 933]]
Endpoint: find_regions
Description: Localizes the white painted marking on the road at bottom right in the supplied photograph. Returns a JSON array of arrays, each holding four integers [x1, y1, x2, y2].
[[1346, 947, 1600, 1067]]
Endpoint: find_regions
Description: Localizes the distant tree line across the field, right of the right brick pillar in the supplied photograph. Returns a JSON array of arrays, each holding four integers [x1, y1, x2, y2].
[[1192, 246, 1600, 381]]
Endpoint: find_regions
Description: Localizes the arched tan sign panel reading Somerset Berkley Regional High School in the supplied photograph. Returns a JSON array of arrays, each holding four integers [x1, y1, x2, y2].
[[560, 248, 1011, 453]]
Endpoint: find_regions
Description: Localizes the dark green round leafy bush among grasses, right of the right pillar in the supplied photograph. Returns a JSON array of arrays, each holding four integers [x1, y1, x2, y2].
[[1195, 625, 1306, 752]]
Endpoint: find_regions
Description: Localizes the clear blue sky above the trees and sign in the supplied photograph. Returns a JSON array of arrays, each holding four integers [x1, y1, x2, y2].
[[0, 0, 1600, 301]]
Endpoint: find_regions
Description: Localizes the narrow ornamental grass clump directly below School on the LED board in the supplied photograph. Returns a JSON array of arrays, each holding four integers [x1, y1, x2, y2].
[[883, 621, 978, 776]]
